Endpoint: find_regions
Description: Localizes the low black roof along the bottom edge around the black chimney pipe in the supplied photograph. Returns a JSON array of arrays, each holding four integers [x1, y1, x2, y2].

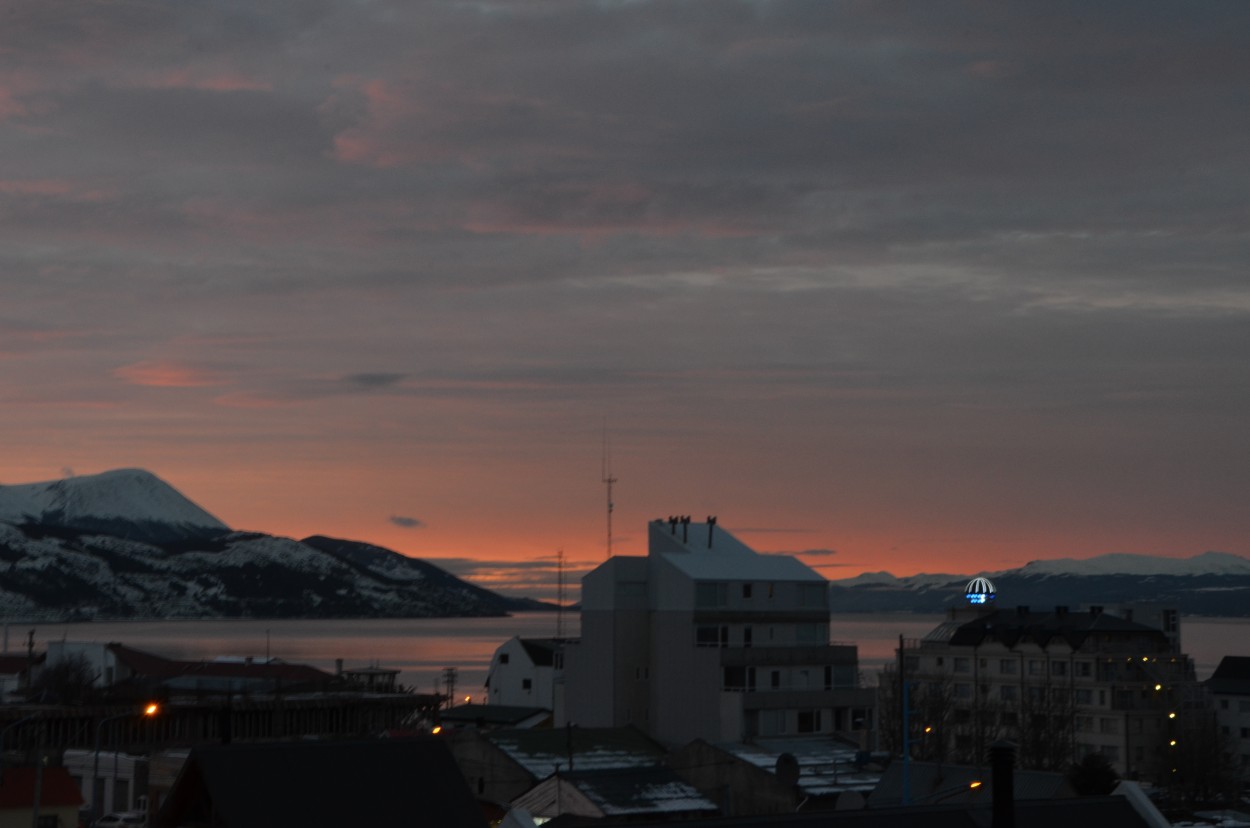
[[548, 797, 1153, 828]]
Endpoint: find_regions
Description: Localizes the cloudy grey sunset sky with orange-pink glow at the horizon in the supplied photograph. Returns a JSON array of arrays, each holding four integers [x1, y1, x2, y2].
[[0, 0, 1250, 597]]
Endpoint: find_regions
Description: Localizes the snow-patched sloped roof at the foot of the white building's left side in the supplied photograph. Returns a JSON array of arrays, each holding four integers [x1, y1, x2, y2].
[[485, 727, 665, 779]]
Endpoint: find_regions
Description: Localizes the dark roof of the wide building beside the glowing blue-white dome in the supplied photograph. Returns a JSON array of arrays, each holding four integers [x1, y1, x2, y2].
[[950, 607, 1170, 650]]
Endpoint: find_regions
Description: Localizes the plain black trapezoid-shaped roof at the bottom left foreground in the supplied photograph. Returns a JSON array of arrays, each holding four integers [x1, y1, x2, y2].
[[156, 738, 486, 828]]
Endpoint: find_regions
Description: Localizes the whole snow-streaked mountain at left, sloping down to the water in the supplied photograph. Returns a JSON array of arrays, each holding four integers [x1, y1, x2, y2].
[[0, 469, 545, 620]]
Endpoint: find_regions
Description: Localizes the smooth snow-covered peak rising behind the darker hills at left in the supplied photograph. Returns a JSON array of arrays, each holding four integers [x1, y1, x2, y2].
[[0, 469, 229, 542]]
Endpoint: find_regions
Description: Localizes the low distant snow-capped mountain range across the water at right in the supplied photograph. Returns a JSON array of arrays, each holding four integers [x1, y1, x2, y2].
[[830, 552, 1250, 617]]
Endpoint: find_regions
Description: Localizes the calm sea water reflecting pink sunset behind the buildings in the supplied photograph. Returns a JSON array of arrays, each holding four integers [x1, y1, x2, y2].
[[5, 613, 1250, 700]]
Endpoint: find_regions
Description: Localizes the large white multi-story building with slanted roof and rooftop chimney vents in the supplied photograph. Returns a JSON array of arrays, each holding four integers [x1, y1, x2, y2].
[[556, 518, 874, 743]]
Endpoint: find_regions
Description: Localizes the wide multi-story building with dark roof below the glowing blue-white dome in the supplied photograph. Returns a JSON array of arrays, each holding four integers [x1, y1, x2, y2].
[[880, 587, 1204, 783]]
